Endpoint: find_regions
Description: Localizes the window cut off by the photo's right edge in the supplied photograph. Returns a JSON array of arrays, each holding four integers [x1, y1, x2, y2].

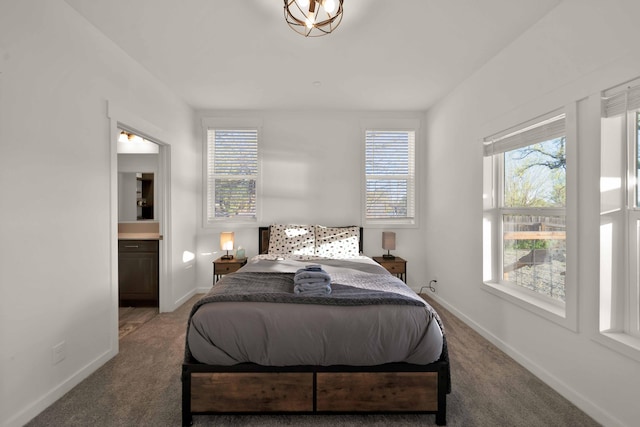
[[600, 79, 640, 352]]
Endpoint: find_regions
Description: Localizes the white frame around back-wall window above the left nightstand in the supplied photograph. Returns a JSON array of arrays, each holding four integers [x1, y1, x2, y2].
[[202, 118, 262, 228]]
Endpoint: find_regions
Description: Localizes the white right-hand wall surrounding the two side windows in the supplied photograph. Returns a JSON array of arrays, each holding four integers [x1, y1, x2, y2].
[[425, 0, 640, 426]]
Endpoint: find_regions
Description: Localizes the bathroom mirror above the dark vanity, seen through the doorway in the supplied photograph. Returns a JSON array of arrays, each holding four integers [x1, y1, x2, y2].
[[118, 172, 155, 222]]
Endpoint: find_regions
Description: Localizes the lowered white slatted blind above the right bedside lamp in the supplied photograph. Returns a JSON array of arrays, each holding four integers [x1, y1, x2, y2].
[[365, 130, 415, 219]]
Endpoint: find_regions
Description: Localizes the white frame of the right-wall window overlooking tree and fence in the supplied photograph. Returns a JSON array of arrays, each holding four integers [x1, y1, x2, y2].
[[481, 103, 578, 331]]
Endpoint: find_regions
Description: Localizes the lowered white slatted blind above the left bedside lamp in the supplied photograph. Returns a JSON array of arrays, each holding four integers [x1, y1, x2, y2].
[[207, 129, 258, 221]]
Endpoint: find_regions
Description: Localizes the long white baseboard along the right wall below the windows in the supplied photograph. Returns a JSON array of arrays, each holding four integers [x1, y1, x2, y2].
[[426, 293, 624, 426]]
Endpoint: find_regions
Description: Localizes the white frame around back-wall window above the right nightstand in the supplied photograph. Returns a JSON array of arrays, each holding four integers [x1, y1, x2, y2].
[[361, 119, 421, 228]]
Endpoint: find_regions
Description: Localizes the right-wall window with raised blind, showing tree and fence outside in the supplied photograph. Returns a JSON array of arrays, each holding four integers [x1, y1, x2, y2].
[[484, 111, 575, 323]]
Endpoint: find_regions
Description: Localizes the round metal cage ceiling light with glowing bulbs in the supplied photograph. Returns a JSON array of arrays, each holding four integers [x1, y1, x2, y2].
[[284, 0, 343, 37]]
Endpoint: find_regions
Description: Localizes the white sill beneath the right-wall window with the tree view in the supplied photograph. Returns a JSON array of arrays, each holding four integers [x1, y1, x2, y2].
[[482, 282, 578, 332]]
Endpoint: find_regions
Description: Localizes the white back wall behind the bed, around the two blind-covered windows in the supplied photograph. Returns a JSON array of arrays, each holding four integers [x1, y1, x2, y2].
[[192, 111, 424, 289]]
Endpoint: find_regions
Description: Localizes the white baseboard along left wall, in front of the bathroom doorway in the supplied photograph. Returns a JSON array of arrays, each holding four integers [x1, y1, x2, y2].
[[3, 349, 118, 427]]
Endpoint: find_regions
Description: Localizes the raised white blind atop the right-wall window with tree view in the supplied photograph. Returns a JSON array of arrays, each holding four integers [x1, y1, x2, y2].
[[484, 112, 566, 156]]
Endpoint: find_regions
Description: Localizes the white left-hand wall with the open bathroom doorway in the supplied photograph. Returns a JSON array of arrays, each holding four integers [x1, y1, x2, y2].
[[0, 0, 198, 426]]
